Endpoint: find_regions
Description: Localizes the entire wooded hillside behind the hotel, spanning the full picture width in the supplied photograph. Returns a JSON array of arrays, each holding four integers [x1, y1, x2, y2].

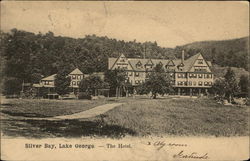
[[0, 29, 248, 87]]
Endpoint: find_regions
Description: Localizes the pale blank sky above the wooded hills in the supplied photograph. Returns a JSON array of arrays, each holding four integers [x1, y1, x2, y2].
[[0, 1, 249, 47]]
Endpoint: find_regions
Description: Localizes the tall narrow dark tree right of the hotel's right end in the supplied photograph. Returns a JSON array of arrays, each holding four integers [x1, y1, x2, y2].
[[224, 68, 239, 102]]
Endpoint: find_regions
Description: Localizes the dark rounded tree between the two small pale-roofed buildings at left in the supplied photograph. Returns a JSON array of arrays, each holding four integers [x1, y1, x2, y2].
[[55, 69, 71, 95]]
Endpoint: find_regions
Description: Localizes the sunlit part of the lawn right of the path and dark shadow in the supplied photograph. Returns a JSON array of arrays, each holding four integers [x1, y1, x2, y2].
[[96, 98, 249, 136]]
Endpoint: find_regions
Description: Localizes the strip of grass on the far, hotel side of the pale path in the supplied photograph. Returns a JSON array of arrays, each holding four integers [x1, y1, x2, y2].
[[1, 99, 106, 117]]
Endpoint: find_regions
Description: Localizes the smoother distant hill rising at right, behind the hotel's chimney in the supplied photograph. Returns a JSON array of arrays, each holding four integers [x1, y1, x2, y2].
[[175, 37, 249, 70]]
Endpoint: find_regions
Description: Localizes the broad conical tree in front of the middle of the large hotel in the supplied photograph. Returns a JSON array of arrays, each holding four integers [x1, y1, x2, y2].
[[142, 64, 172, 99]]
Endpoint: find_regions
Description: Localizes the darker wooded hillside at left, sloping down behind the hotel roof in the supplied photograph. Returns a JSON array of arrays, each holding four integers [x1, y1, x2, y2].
[[1, 29, 174, 83]]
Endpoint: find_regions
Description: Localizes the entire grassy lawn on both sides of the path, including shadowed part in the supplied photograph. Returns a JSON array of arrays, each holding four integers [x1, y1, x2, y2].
[[1, 98, 250, 137]]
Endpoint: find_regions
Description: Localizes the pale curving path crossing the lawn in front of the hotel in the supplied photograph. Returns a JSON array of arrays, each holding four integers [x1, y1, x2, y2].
[[1, 103, 123, 120]]
